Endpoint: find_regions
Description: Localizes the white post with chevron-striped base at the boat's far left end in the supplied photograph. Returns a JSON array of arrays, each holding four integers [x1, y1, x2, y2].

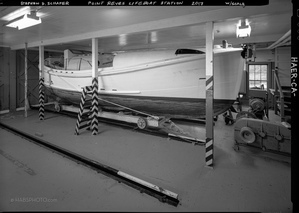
[[38, 46, 45, 120]]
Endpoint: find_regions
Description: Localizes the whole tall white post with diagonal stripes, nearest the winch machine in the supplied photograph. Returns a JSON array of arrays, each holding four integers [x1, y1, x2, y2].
[[205, 22, 214, 168]]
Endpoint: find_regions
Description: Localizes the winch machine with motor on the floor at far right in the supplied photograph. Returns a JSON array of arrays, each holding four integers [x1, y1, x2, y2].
[[234, 98, 291, 156]]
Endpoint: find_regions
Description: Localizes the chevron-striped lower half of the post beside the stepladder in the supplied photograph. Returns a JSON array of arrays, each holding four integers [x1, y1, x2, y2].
[[91, 78, 99, 135]]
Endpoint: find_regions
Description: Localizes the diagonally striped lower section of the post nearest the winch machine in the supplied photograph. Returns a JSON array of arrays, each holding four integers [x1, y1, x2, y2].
[[205, 76, 214, 167]]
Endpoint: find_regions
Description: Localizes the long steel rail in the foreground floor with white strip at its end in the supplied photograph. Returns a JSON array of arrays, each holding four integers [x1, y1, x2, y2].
[[0, 122, 180, 207]]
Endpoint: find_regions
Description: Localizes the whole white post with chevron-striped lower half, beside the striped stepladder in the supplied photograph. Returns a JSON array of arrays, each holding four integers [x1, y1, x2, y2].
[[91, 38, 99, 135]]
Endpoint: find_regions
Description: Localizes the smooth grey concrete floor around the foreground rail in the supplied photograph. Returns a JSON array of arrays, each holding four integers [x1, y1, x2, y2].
[[0, 110, 292, 212]]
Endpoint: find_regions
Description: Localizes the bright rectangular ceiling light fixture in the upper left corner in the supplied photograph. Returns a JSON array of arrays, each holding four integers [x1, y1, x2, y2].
[[5, 11, 42, 30]]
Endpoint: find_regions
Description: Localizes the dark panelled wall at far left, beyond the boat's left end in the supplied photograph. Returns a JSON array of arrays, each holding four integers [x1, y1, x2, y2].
[[0, 47, 63, 112]]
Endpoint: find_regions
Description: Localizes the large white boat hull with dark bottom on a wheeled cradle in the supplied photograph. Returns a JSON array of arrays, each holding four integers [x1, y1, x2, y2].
[[44, 48, 244, 118]]
